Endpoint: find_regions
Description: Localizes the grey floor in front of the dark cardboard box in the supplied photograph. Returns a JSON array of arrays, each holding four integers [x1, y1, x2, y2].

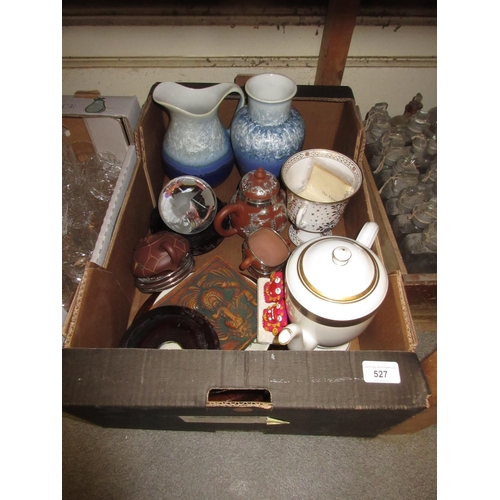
[[62, 415, 437, 500]]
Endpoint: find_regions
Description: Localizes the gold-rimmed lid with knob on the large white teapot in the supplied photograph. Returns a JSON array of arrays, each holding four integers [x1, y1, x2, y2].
[[297, 236, 379, 303]]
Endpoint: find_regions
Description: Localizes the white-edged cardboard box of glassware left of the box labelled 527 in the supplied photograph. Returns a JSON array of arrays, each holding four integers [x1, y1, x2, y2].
[[62, 92, 141, 326]]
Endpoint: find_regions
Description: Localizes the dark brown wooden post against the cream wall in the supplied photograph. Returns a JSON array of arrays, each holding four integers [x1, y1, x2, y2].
[[314, 0, 360, 85]]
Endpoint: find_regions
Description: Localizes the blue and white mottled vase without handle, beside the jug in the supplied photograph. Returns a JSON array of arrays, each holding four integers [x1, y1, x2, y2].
[[230, 73, 305, 178]]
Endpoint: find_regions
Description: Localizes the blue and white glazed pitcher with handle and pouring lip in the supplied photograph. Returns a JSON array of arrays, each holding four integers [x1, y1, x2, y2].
[[153, 82, 245, 187]]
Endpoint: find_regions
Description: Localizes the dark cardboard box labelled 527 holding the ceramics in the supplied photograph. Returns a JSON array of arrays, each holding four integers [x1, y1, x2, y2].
[[62, 86, 429, 436]]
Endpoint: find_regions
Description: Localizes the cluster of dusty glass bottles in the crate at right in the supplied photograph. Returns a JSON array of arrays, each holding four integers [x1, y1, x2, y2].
[[365, 94, 437, 273]]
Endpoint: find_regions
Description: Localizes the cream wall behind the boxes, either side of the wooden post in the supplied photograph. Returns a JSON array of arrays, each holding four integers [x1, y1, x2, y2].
[[62, 26, 437, 116]]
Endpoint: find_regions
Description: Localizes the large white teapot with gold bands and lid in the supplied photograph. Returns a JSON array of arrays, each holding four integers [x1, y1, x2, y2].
[[278, 222, 389, 350]]
